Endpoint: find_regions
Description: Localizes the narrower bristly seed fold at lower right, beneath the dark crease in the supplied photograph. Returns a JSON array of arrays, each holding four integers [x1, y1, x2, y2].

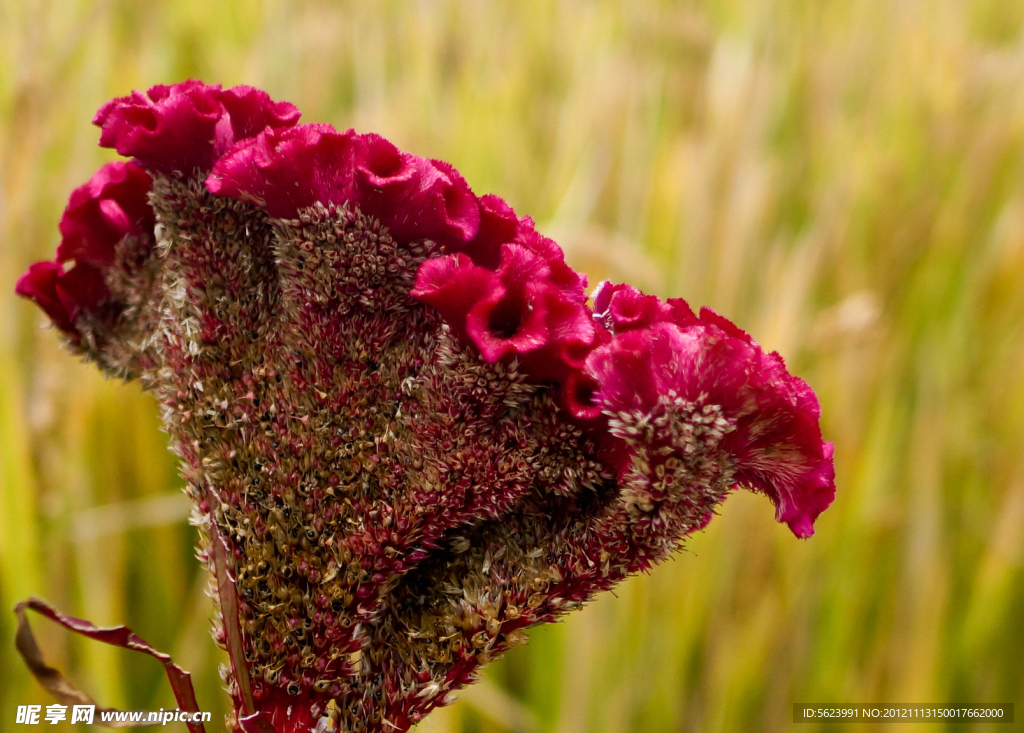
[[360, 400, 734, 722]]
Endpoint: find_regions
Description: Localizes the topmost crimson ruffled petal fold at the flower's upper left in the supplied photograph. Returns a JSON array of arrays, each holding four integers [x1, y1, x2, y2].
[[93, 80, 299, 175]]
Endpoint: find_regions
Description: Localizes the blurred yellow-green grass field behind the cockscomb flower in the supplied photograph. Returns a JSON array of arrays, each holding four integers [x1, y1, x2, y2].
[[0, 0, 1024, 733]]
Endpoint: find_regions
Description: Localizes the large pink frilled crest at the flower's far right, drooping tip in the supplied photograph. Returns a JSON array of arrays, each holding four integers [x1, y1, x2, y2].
[[586, 286, 836, 537]]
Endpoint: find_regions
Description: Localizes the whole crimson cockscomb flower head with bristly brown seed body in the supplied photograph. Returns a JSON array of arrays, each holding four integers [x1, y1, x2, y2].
[[17, 81, 835, 733]]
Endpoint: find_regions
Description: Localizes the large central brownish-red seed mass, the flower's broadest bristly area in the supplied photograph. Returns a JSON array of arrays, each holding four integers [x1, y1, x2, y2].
[[70, 176, 610, 730]]
